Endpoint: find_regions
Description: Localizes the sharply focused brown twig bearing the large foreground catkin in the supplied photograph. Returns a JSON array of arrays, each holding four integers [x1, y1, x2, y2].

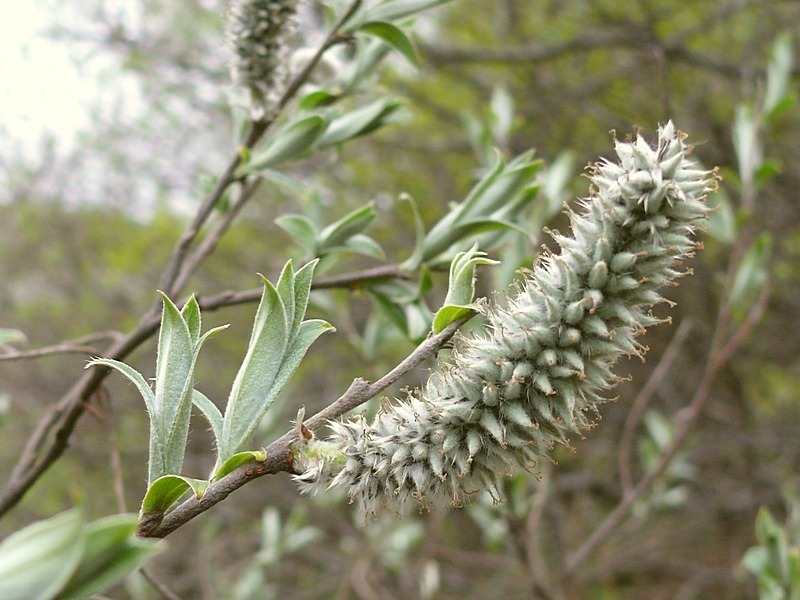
[[138, 316, 471, 538]]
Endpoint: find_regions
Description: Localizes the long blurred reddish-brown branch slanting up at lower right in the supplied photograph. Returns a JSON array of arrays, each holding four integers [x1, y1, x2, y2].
[[565, 285, 769, 575]]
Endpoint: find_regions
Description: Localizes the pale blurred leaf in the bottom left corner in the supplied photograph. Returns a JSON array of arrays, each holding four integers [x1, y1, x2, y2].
[[0, 508, 86, 600]]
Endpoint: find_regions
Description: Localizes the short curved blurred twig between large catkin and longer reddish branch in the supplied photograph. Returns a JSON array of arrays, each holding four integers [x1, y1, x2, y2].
[[617, 319, 692, 495]]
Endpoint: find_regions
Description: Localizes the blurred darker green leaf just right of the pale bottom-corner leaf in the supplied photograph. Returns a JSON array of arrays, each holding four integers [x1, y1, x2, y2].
[[60, 514, 164, 600]]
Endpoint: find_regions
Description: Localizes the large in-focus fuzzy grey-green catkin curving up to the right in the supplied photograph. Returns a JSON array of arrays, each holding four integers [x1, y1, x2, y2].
[[295, 122, 716, 518]]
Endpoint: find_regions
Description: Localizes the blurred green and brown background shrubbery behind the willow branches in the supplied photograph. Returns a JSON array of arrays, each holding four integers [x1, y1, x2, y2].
[[0, 0, 800, 600]]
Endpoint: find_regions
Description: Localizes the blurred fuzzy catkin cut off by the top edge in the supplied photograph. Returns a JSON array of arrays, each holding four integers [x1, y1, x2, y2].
[[226, 0, 297, 118]]
